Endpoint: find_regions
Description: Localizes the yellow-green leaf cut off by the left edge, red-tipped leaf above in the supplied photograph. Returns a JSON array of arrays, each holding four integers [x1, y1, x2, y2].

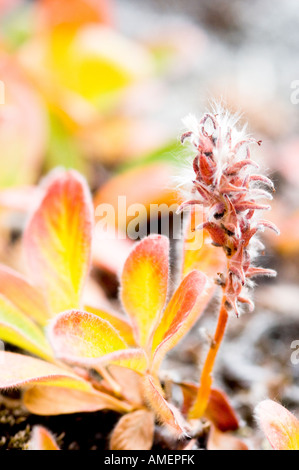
[[0, 294, 53, 360]]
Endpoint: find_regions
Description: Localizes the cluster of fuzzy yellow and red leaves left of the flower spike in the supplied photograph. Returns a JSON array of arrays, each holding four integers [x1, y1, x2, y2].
[[0, 171, 229, 449]]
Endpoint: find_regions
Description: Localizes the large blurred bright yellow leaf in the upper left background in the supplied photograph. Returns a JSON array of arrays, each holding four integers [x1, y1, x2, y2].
[[19, 23, 153, 114]]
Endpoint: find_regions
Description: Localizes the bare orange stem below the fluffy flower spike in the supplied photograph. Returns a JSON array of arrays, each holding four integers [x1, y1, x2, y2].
[[189, 295, 228, 419]]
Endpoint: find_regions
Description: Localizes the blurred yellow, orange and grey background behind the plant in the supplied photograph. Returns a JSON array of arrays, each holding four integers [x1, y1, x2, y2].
[[0, 0, 299, 448]]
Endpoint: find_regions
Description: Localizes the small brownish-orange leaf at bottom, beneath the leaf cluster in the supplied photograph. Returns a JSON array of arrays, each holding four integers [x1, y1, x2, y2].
[[110, 409, 155, 450]]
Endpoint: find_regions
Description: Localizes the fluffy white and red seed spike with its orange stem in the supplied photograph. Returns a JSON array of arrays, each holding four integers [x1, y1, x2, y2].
[[181, 110, 278, 418]]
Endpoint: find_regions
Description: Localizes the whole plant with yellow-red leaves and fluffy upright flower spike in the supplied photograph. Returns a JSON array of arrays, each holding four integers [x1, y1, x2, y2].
[[0, 108, 276, 450]]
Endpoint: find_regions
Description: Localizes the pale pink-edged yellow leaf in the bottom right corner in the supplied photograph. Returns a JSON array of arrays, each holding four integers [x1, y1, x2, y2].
[[255, 400, 299, 450]]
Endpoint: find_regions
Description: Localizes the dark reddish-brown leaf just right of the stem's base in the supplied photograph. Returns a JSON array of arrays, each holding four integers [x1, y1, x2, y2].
[[205, 389, 239, 432]]
